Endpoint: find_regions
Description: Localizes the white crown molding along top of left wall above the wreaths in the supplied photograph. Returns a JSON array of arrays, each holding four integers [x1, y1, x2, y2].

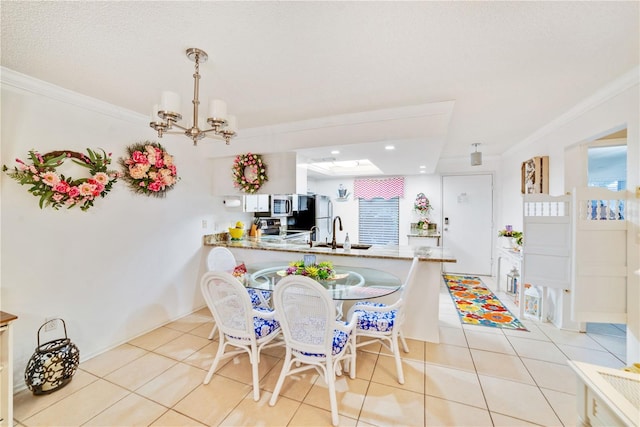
[[0, 67, 149, 124]]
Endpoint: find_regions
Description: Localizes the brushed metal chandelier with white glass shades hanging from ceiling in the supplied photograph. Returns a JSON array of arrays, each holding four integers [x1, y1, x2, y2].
[[149, 47, 237, 145]]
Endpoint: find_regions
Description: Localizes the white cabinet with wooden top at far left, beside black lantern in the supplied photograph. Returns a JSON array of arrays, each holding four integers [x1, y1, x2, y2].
[[0, 311, 18, 427]]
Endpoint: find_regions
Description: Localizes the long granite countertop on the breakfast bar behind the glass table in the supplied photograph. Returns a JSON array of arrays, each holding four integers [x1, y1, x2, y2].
[[203, 234, 456, 262]]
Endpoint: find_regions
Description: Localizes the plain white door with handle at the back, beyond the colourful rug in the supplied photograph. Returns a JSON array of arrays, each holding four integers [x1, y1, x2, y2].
[[441, 175, 493, 276]]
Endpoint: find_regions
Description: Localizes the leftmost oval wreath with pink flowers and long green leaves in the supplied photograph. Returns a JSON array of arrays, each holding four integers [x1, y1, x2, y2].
[[2, 148, 119, 211]]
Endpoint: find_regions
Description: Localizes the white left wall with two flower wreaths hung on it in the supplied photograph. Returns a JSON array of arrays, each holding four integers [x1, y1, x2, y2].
[[0, 70, 216, 389]]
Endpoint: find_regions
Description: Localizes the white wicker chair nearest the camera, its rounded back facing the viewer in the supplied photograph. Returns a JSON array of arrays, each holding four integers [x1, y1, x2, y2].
[[269, 276, 356, 426]]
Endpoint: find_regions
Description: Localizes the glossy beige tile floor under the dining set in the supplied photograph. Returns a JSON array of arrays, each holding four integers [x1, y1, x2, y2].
[[14, 278, 625, 427]]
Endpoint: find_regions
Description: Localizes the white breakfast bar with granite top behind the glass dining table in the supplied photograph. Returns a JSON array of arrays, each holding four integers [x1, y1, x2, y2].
[[203, 235, 456, 343]]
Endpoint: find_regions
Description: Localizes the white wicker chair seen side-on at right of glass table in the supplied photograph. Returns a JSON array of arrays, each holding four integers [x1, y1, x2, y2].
[[349, 258, 418, 384]]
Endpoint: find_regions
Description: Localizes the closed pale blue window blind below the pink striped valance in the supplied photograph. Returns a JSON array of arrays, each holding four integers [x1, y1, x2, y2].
[[358, 197, 400, 245]]
